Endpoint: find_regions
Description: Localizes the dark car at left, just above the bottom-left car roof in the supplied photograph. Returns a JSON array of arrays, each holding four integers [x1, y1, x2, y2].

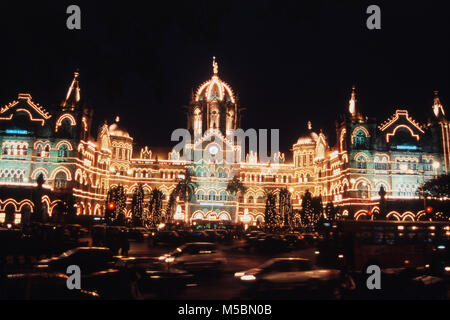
[[35, 247, 116, 274]]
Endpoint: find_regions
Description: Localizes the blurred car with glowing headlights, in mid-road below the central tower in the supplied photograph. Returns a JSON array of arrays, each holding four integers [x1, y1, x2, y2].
[[159, 242, 226, 271]]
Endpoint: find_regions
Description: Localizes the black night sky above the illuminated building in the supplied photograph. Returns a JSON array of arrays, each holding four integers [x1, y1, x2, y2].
[[0, 0, 450, 151]]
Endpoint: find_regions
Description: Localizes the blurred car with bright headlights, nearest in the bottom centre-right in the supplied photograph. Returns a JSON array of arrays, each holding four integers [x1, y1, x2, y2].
[[234, 257, 342, 297]]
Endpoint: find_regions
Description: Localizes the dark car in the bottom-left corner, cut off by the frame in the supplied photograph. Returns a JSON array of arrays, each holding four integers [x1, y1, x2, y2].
[[0, 272, 100, 300]]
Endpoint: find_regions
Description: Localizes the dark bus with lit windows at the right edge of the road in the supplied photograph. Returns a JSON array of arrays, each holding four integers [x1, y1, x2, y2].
[[316, 221, 450, 272]]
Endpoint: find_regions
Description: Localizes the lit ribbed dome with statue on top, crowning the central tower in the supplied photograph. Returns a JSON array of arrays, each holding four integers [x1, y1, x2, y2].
[[195, 57, 235, 103]]
